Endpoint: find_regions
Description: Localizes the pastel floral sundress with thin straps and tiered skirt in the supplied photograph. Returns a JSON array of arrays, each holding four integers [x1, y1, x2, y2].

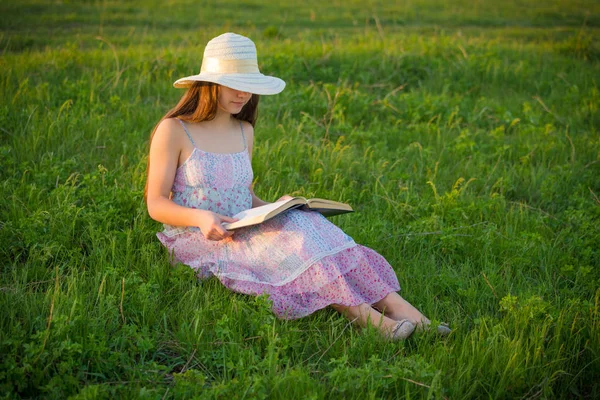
[[157, 120, 400, 319]]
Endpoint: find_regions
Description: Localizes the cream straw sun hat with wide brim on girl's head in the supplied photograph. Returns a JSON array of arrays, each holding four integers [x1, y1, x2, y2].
[[173, 32, 285, 94]]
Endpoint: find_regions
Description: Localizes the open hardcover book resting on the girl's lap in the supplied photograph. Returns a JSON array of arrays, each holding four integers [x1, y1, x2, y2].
[[223, 197, 354, 231]]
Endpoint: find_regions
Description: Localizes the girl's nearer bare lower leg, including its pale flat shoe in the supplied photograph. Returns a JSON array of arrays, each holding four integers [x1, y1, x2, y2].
[[332, 303, 415, 339]]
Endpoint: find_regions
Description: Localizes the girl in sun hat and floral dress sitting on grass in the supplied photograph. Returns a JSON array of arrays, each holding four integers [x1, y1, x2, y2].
[[146, 33, 449, 339]]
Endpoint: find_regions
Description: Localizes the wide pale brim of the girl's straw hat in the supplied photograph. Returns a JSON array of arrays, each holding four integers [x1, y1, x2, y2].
[[173, 73, 285, 95]]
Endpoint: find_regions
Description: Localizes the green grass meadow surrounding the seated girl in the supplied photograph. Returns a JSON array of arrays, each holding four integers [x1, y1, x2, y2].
[[0, 0, 600, 399]]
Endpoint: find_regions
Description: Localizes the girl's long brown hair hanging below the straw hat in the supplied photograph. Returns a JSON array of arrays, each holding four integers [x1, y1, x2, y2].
[[144, 82, 260, 200]]
